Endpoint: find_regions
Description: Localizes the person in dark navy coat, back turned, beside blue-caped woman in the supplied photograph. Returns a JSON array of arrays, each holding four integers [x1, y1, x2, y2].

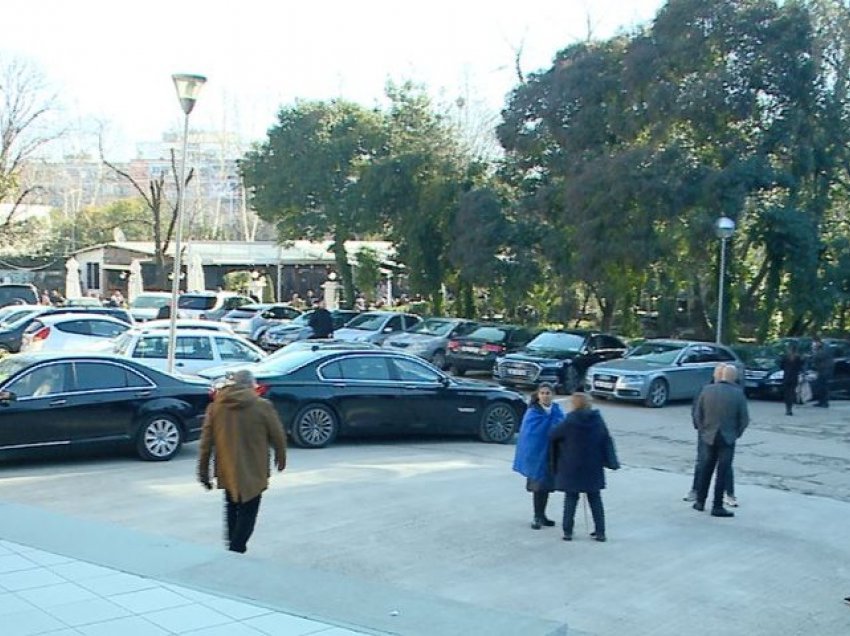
[[549, 392, 620, 541]]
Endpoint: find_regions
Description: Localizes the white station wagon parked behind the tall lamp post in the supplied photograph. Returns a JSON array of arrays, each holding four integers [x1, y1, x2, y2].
[[113, 329, 266, 374]]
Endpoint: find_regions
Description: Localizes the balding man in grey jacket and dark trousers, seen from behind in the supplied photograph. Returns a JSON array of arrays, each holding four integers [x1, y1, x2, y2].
[[693, 364, 750, 517]]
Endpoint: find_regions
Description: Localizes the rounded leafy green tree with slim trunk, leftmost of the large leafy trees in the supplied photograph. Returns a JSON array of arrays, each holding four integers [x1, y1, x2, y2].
[[239, 100, 386, 307]]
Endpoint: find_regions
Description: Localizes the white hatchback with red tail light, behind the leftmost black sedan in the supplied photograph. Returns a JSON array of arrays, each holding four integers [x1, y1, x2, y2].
[[21, 313, 130, 353]]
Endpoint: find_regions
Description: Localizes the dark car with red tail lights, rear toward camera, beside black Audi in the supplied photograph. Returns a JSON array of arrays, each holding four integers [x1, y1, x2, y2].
[[446, 323, 537, 375]]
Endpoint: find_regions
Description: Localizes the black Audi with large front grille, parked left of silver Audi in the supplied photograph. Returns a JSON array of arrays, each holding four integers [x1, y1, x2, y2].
[[493, 329, 628, 393]]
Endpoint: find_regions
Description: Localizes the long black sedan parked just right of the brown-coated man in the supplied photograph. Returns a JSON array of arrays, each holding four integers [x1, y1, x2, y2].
[[202, 349, 525, 448]]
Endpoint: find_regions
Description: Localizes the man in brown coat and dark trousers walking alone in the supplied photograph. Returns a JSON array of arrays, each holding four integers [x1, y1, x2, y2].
[[198, 370, 286, 552]]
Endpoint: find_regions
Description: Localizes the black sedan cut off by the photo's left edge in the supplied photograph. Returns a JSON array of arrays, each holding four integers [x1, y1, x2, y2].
[[0, 353, 210, 461]]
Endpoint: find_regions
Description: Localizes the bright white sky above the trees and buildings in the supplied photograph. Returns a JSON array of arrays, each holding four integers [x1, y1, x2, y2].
[[0, 0, 663, 155]]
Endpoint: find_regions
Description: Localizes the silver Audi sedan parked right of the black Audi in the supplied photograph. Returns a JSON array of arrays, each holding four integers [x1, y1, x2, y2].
[[585, 340, 744, 408]]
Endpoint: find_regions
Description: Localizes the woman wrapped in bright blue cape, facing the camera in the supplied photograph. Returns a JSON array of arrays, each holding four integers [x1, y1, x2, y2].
[[513, 382, 564, 530]]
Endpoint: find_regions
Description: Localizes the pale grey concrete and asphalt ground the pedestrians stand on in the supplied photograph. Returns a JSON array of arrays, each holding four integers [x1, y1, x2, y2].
[[0, 402, 850, 636]]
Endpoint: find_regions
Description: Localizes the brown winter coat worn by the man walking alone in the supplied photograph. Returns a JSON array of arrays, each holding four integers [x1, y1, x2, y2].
[[198, 387, 286, 501]]
